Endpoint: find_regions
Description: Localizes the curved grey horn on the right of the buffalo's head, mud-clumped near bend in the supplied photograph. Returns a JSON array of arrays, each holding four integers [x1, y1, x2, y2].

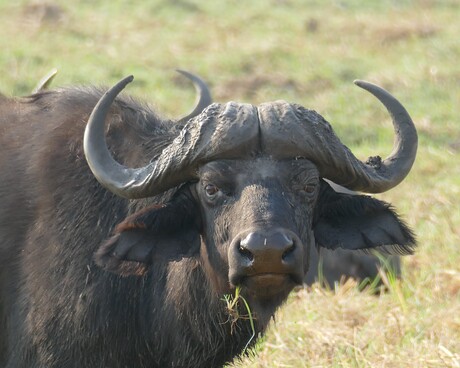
[[259, 81, 418, 193]]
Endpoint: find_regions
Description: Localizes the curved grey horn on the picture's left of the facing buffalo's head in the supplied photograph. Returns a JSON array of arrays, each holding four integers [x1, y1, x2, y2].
[[83, 73, 258, 199]]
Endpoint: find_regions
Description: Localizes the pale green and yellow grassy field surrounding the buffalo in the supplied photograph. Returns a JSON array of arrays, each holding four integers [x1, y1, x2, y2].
[[0, 0, 460, 367]]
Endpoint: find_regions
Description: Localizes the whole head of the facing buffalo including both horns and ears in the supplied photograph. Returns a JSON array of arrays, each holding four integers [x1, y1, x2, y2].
[[84, 77, 417, 319]]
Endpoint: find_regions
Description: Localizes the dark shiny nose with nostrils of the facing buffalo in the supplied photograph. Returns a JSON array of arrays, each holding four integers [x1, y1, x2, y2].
[[238, 231, 296, 267]]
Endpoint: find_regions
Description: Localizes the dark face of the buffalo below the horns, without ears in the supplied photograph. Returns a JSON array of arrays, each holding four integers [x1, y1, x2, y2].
[[195, 158, 319, 316]]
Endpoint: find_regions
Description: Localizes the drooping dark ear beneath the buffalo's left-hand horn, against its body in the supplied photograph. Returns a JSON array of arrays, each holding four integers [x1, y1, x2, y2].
[[94, 193, 200, 276]]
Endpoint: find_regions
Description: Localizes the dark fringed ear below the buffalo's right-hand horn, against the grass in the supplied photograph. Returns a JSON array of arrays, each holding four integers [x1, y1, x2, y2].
[[313, 181, 416, 254]]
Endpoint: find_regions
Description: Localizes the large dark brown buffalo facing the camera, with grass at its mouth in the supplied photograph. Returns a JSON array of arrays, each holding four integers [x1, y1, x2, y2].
[[0, 72, 417, 368]]
